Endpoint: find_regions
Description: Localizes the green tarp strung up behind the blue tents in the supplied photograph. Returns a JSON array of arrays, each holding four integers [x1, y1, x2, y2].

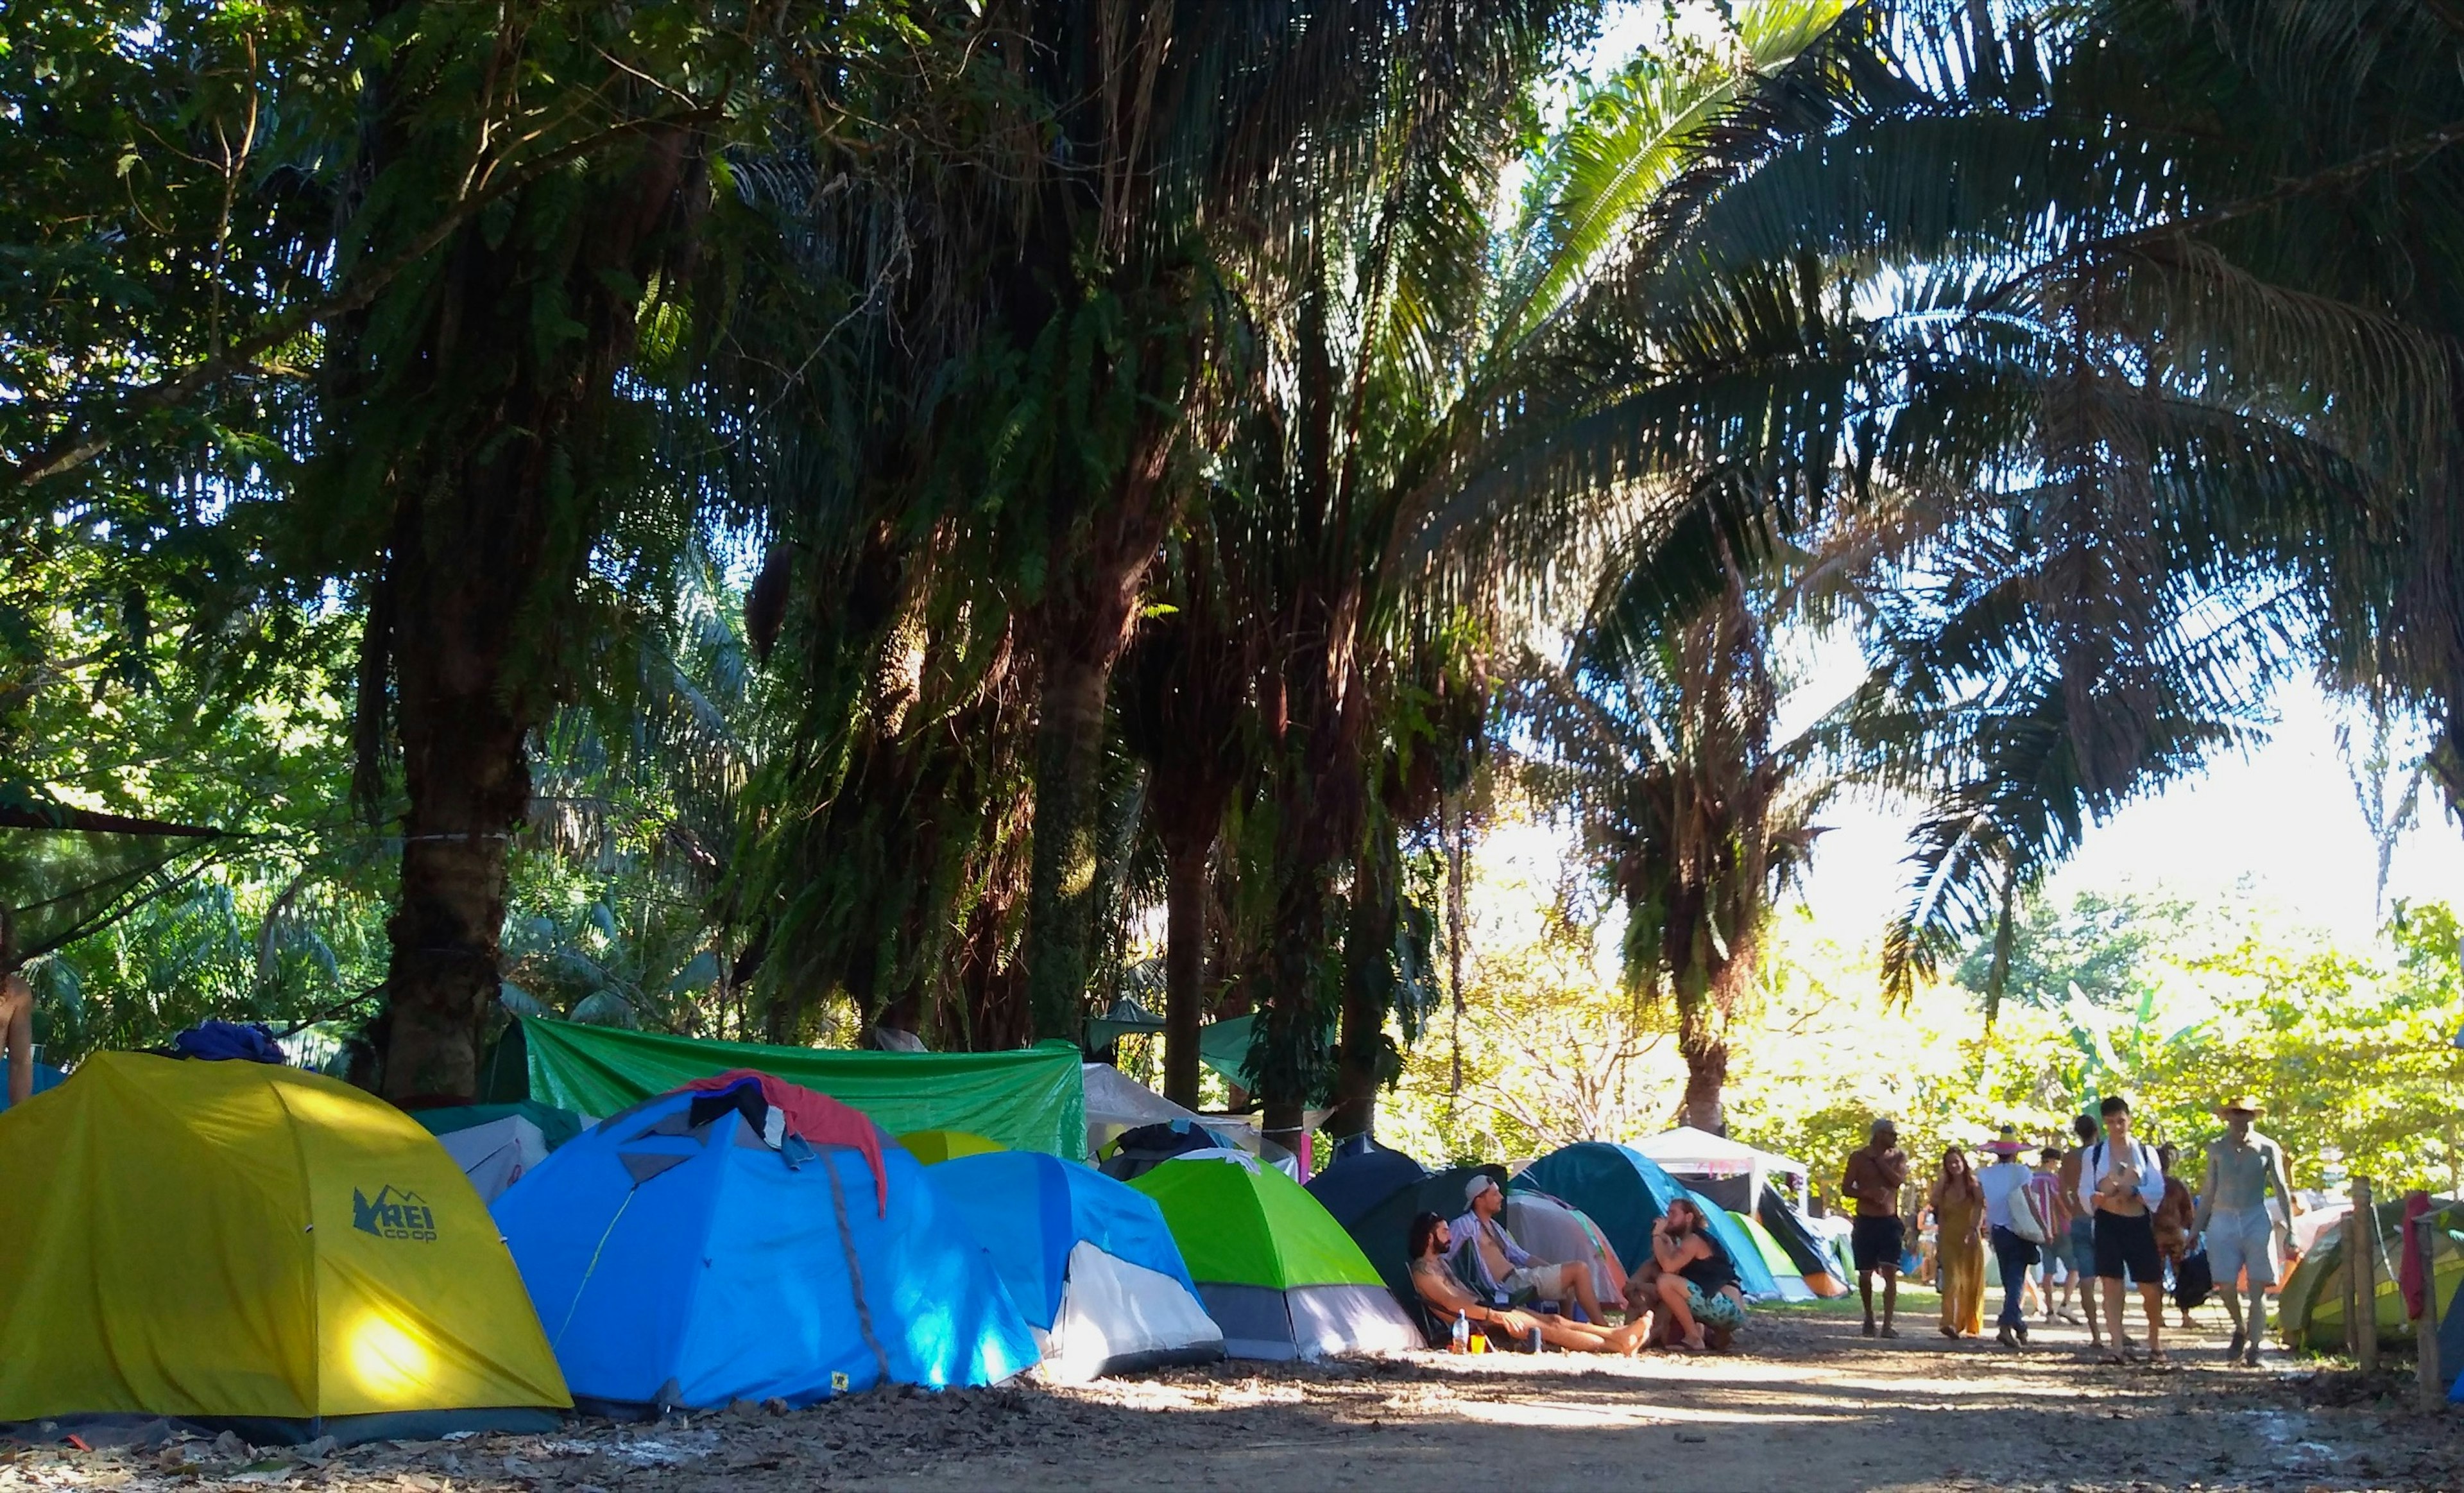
[[522, 1015, 1086, 1161]]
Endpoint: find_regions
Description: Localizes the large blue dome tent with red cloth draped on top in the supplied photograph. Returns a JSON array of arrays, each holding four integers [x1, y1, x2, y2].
[[495, 1074, 1035, 1414]]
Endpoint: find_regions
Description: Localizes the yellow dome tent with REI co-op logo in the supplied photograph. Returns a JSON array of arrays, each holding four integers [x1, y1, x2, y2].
[[0, 1052, 572, 1441]]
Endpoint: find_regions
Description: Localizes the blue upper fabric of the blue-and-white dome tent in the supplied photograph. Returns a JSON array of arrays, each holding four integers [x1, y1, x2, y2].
[[932, 1150, 1197, 1331]]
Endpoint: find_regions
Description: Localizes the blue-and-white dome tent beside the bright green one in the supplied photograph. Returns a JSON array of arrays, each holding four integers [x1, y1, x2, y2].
[[934, 1150, 1224, 1382]]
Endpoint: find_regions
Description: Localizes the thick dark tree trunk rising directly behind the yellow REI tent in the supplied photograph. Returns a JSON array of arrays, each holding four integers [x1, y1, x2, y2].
[[332, 117, 700, 1101]]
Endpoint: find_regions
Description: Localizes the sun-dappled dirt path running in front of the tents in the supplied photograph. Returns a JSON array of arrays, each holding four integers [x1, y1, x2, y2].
[[0, 1311, 2464, 1493]]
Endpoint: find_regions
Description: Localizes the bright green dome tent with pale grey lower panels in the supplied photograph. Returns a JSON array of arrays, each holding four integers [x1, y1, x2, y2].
[[1131, 1158, 1422, 1360]]
